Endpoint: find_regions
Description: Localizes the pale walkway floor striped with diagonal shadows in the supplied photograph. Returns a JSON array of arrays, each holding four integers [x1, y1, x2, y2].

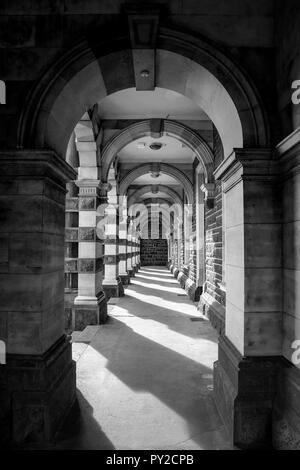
[[57, 267, 230, 450]]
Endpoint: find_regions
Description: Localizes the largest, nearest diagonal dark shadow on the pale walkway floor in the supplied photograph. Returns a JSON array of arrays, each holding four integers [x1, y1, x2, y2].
[[84, 318, 230, 448]]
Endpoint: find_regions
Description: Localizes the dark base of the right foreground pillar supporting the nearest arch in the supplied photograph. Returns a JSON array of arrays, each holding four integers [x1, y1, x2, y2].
[[214, 336, 280, 449]]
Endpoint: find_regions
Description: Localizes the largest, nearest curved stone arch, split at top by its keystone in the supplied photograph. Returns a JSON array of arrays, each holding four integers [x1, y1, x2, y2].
[[18, 28, 270, 158]]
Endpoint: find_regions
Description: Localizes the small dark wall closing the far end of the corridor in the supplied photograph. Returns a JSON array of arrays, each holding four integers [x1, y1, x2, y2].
[[141, 238, 168, 266]]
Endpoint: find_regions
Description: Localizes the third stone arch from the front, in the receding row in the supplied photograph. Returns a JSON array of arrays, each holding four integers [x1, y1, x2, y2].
[[119, 163, 193, 204]]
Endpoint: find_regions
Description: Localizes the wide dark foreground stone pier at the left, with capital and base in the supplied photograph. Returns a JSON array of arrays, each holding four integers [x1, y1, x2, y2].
[[0, 150, 76, 444]]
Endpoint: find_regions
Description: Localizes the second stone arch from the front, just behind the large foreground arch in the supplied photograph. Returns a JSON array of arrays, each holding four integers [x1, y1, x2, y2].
[[101, 119, 214, 182]]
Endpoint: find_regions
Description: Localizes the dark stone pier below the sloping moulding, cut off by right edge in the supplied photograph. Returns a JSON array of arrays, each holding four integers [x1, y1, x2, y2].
[[273, 130, 300, 449]]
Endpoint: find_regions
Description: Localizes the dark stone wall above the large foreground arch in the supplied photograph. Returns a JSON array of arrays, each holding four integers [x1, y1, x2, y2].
[[0, 0, 276, 148]]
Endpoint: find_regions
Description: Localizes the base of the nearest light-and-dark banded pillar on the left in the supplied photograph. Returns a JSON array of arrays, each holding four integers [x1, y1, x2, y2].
[[72, 291, 108, 331]]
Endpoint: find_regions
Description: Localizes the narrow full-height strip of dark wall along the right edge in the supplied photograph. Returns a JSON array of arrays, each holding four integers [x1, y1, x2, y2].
[[273, 4, 300, 449]]
